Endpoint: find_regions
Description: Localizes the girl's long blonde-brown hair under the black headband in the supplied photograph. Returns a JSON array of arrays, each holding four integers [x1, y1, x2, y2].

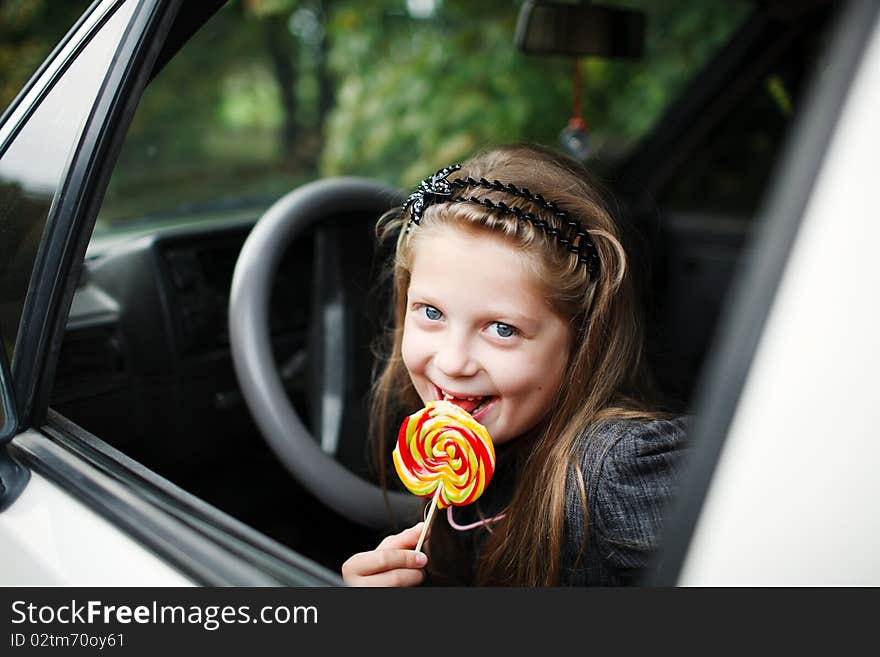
[[371, 144, 659, 586]]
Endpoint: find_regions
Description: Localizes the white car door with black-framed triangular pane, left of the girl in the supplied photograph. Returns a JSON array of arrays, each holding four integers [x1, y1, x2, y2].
[[0, 0, 341, 585]]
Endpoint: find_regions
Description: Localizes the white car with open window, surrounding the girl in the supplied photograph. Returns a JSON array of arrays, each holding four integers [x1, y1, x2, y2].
[[0, 0, 880, 586]]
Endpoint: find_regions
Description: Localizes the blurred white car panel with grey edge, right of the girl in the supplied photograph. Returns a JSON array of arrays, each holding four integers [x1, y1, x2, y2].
[[651, 2, 880, 586]]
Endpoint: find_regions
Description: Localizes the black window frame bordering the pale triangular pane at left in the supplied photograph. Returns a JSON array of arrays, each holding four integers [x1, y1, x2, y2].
[[11, 0, 174, 430]]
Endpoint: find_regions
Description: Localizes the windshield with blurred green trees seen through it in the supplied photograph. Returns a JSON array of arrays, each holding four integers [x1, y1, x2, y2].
[[95, 0, 749, 236]]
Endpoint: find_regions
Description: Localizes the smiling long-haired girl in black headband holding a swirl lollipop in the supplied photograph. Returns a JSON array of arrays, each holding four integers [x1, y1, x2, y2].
[[342, 145, 685, 586]]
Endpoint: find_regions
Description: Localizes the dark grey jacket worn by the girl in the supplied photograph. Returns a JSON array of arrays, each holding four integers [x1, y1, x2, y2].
[[428, 417, 688, 586]]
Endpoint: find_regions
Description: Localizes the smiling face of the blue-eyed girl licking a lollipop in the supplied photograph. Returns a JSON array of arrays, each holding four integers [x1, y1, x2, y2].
[[403, 226, 570, 444]]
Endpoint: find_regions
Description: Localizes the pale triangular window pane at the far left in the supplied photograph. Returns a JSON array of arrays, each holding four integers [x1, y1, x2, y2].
[[0, 2, 137, 363]]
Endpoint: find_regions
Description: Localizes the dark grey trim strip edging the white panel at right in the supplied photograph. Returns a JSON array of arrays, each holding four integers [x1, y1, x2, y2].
[[644, 0, 880, 586]]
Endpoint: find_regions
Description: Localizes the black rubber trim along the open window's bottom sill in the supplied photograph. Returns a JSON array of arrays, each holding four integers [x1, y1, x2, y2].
[[10, 412, 343, 586]]
